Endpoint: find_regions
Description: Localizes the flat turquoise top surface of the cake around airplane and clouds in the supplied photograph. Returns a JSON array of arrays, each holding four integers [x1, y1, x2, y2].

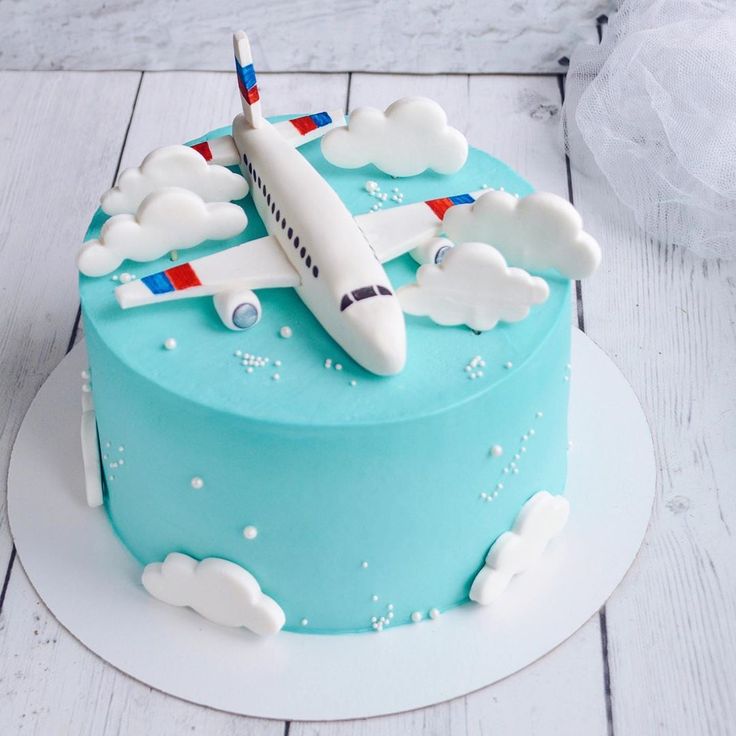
[[80, 122, 570, 425]]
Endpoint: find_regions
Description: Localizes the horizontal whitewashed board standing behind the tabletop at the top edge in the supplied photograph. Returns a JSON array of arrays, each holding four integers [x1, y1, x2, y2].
[[0, 0, 614, 73]]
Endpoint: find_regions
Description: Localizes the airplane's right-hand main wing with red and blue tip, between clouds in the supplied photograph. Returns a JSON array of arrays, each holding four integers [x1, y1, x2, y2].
[[355, 189, 488, 263]]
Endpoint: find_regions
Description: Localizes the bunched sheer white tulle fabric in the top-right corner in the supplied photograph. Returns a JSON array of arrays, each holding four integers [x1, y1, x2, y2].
[[564, 0, 736, 258]]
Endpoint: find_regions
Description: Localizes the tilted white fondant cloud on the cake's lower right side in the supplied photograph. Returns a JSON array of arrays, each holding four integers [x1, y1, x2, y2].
[[470, 491, 570, 605]]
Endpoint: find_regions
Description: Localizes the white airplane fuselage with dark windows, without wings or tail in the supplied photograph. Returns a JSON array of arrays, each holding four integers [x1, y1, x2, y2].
[[233, 115, 406, 375]]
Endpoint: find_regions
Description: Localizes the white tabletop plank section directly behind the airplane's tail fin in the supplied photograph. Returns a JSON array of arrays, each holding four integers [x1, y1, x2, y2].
[[121, 72, 348, 168]]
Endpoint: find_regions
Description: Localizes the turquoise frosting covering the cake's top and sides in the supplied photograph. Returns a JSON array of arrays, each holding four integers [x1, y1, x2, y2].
[[80, 121, 570, 633]]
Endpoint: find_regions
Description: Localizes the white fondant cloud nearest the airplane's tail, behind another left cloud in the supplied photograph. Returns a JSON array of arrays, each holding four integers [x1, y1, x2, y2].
[[101, 146, 248, 215]]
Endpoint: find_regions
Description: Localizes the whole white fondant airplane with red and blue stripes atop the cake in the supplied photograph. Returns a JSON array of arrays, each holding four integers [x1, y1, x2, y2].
[[115, 31, 482, 375]]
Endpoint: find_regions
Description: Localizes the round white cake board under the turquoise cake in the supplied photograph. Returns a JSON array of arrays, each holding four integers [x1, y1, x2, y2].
[[8, 331, 655, 720]]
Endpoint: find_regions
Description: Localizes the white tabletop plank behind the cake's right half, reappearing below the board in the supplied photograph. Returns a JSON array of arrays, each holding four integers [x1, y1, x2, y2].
[[290, 74, 607, 736]]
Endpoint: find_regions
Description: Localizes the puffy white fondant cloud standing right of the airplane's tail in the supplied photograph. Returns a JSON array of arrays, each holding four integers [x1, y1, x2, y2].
[[322, 97, 468, 176]]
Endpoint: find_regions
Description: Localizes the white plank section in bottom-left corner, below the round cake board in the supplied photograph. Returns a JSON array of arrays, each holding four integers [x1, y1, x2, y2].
[[0, 563, 284, 736]]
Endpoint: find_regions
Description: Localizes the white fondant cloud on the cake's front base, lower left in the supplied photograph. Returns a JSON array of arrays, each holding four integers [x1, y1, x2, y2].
[[141, 552, 286, 636]]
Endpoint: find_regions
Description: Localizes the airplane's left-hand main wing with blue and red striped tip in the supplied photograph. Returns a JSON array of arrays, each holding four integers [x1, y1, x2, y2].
[[115, 235, 301, 309]]
